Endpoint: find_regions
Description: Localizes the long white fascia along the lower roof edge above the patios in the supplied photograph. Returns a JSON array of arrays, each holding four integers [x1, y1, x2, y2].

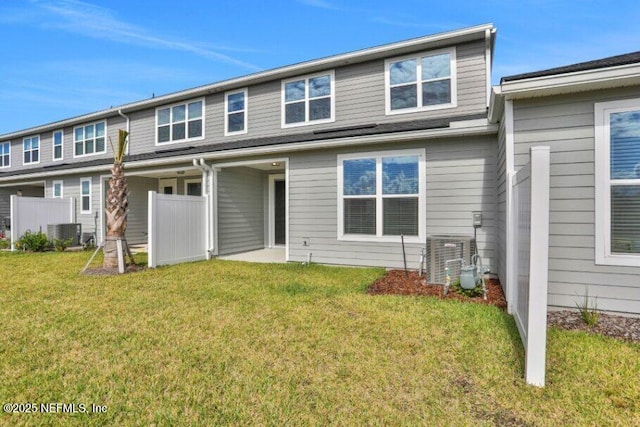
[[0, 121, 498, 186]]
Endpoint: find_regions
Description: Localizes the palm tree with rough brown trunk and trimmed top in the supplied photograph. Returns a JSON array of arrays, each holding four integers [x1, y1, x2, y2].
[[103, 129, 133, 272]]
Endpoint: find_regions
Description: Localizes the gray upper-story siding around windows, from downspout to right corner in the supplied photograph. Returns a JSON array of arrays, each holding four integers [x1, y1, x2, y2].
[[81, 41, 487, 159]]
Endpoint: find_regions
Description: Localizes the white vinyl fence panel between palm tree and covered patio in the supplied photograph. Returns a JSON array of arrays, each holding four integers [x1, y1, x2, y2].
[[148, 191, 207, 267]]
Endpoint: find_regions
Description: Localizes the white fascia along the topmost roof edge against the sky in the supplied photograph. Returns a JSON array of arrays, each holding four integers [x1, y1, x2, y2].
[[0, 24, 494, 141]]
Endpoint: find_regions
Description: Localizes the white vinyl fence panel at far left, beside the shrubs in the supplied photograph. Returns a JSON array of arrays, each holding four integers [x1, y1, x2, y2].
[[10, 195, 75, 250]]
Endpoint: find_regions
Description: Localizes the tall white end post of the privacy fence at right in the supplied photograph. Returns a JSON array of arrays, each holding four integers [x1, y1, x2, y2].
[[525, 147, 550, 387]]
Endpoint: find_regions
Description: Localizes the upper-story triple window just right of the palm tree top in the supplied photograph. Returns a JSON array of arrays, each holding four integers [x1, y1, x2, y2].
[[156, 99, 204, 144]]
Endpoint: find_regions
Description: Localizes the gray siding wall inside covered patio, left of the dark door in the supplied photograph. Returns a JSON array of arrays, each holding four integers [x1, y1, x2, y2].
[[218, 167, 266, 255]]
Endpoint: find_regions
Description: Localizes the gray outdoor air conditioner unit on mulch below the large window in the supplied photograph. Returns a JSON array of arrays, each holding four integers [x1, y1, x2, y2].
[[426, 235, 476, 284]]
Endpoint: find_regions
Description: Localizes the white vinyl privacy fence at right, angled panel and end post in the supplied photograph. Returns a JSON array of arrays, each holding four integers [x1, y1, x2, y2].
[[509, 147, 550, 387]]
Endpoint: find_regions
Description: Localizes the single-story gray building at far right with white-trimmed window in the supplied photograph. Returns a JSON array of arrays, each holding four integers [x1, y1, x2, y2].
[[490, 52, 640, 314]]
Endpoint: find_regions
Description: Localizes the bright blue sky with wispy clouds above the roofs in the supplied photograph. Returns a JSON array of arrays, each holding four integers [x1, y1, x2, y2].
[[0, 0, 640, 134]]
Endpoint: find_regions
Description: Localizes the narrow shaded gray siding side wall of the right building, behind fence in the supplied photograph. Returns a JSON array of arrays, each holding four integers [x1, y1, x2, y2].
[[495, 120, 508, 287]]
